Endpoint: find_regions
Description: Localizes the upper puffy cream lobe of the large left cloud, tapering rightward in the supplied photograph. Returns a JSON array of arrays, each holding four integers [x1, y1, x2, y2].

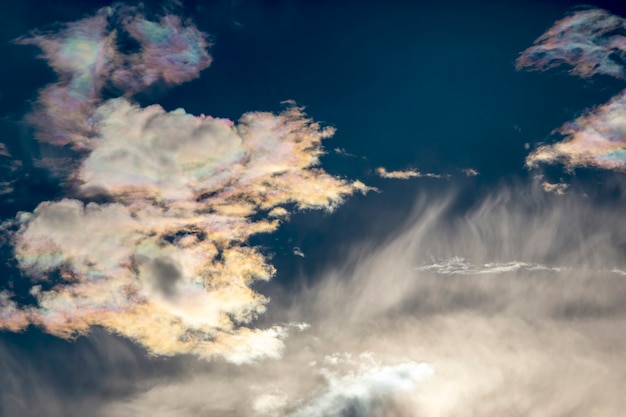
[[77, 99, 366, 208]]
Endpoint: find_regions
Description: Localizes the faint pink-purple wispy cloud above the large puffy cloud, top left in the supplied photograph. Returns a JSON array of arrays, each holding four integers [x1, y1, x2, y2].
[[16, 5, 211, 150]]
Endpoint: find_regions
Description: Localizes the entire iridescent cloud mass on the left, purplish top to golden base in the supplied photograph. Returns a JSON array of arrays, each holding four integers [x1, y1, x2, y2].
[[0, 6, 367, 363]]
